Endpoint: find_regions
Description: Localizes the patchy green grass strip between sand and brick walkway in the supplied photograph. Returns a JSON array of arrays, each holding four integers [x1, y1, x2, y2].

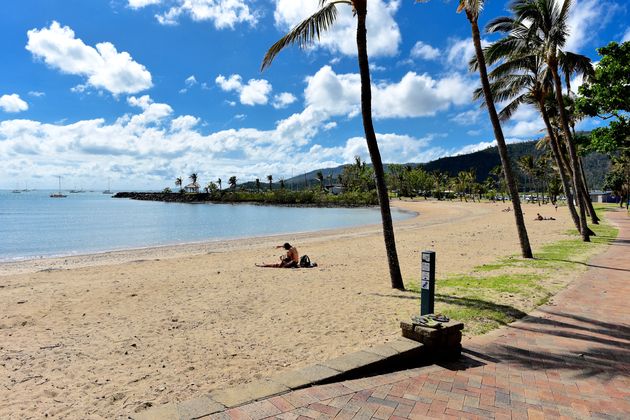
[[407, 205, 618, 335]]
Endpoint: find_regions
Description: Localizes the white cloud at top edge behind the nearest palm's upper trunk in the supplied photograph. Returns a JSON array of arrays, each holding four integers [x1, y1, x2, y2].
[[274, 0, 401, 57]]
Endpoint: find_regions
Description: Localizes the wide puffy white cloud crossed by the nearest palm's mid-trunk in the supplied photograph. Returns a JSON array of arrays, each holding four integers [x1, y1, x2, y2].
[[304, 66, 474, 118]]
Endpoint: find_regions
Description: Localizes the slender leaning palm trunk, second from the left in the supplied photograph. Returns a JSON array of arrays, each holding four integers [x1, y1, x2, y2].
[[466, 16, 533, 258]]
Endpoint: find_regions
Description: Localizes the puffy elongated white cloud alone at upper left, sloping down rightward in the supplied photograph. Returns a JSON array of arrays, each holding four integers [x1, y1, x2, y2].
[[26, 22, 153, 95]]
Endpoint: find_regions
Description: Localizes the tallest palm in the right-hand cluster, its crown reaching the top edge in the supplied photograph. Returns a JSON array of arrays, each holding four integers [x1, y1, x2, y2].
[[511, 0, 590, 242]]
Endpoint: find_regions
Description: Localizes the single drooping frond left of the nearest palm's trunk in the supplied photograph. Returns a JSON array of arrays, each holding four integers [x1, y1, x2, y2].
[[260, 0, 352, 71]]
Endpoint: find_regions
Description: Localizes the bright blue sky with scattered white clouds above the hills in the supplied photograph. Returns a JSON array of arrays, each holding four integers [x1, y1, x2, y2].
[[0, 0, 630, 190]]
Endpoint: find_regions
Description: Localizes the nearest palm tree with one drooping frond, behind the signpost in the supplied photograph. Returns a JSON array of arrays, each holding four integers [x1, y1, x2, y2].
[[262, 0, 405, 290]]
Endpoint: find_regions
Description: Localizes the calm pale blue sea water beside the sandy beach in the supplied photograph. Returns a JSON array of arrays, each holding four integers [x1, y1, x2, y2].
[[0, 191, 409, 261]]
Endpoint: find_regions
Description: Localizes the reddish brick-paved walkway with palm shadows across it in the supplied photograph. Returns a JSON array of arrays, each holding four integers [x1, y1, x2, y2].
[[208, 212, 630, 419]]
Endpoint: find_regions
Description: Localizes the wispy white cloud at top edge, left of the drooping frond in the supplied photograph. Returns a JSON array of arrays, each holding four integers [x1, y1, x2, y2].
[[152, 0, 258, 29]]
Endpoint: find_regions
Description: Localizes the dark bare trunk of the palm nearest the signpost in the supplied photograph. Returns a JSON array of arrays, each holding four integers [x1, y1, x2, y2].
[[355, 6, 405, 290]]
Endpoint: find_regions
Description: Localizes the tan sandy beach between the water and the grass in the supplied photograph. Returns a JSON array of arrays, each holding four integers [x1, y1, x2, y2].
[[0, 201, 572, 419]]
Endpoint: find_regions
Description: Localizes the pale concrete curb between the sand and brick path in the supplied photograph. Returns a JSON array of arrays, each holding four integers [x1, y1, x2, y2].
[[136, 337, 424, 420]]
